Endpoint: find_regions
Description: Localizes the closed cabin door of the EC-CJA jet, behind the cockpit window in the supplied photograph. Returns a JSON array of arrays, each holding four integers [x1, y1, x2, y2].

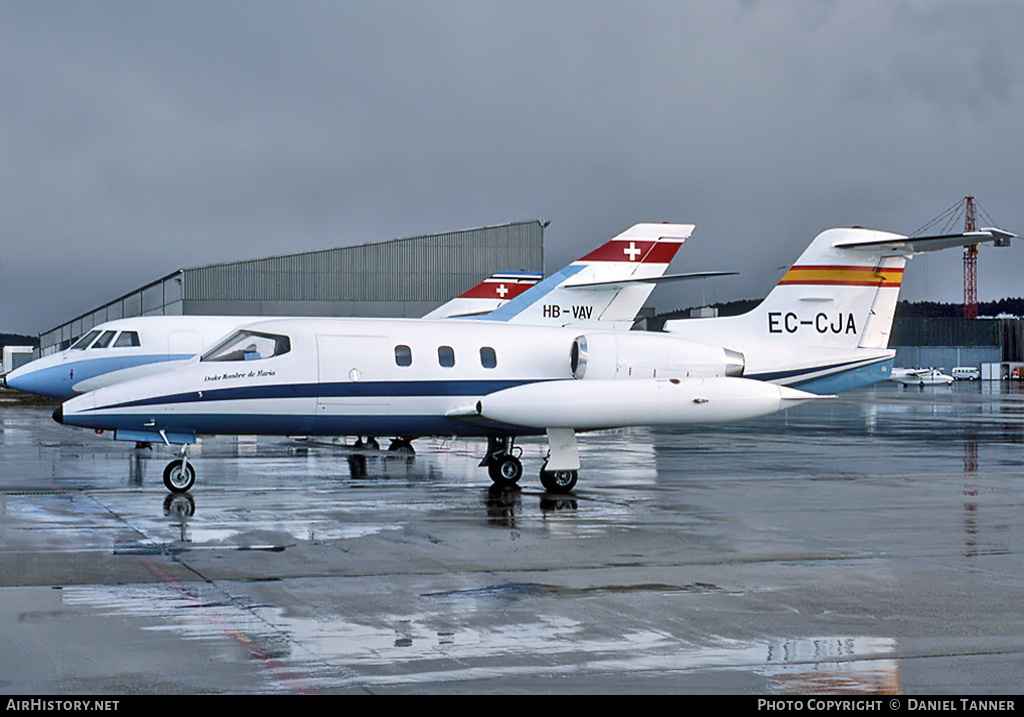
[[316, 336, 391, 435]]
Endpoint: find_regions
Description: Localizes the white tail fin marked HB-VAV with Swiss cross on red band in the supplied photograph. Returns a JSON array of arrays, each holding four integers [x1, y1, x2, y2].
[[483, 224, 693, 329]]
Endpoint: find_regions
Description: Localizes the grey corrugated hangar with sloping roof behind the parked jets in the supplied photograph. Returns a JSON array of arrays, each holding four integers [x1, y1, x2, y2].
[[39, 220, 547, 355]]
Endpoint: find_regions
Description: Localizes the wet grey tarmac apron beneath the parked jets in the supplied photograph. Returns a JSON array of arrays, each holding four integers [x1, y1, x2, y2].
[[0, 382, 1024, 695]]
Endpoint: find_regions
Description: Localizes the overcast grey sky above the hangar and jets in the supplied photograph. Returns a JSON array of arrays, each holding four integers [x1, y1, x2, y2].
[[0, 0, 1024, 334]]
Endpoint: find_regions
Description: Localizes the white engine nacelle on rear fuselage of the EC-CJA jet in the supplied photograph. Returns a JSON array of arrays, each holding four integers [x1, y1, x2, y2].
[[569, 331, 744, 380]]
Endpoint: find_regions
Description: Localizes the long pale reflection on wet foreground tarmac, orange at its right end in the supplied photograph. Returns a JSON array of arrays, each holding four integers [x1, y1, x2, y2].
[[54, 585, 899, 693]]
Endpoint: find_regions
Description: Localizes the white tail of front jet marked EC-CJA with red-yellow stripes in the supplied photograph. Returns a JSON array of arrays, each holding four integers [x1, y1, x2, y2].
[[665, 227, 1013, 392]]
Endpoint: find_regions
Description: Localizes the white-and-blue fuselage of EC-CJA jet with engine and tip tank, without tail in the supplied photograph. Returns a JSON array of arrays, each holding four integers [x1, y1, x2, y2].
[[58, 319, 798, 442]]
